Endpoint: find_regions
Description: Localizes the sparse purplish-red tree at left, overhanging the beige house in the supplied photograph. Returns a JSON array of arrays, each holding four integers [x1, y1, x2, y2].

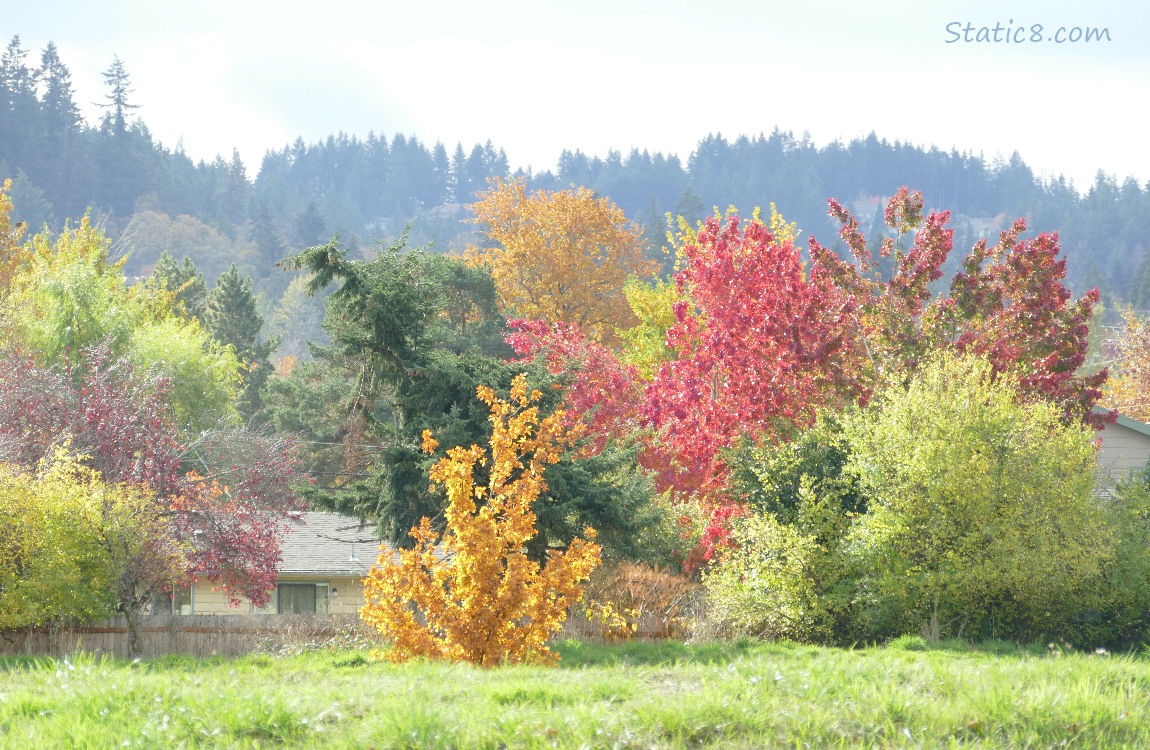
[[0, 349, 300, 648]]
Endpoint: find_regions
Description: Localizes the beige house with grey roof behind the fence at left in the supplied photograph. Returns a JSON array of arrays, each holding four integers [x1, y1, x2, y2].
[[174, 512, 380, 614]]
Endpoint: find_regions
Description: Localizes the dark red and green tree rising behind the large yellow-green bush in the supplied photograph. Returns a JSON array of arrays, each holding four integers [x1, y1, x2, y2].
[[810, 188, 1106, 427]]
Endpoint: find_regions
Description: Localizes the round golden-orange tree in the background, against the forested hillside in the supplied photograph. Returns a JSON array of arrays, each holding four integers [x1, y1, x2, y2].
[[468, 179, 658, 342]]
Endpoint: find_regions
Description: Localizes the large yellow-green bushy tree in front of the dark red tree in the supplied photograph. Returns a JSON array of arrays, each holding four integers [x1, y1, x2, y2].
[[846, 354, 1114, 640]]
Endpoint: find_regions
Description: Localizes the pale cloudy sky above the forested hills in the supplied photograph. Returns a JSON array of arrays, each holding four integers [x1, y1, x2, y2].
[[0, 0, 1150, 190]]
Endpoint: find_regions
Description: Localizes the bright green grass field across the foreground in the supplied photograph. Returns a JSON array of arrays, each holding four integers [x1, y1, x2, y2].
[[0, 641, 1150, 749]]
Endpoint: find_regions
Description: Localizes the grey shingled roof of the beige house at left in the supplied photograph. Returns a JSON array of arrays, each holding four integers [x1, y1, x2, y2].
[[279, 512, 393, 576]]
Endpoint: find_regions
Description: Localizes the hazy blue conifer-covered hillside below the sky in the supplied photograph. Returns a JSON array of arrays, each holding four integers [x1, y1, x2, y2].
[[0, 37, 1150, 314]]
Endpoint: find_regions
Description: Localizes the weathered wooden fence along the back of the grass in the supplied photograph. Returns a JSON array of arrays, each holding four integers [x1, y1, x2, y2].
[[0, 613, 683, 658]]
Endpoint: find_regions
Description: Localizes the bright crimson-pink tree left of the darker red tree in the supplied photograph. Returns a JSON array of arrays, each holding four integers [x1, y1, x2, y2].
[[644, 216, 857, 505]]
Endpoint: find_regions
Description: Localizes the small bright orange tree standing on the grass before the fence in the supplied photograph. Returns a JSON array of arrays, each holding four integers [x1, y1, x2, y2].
[[360, 375, 600, 667]]
